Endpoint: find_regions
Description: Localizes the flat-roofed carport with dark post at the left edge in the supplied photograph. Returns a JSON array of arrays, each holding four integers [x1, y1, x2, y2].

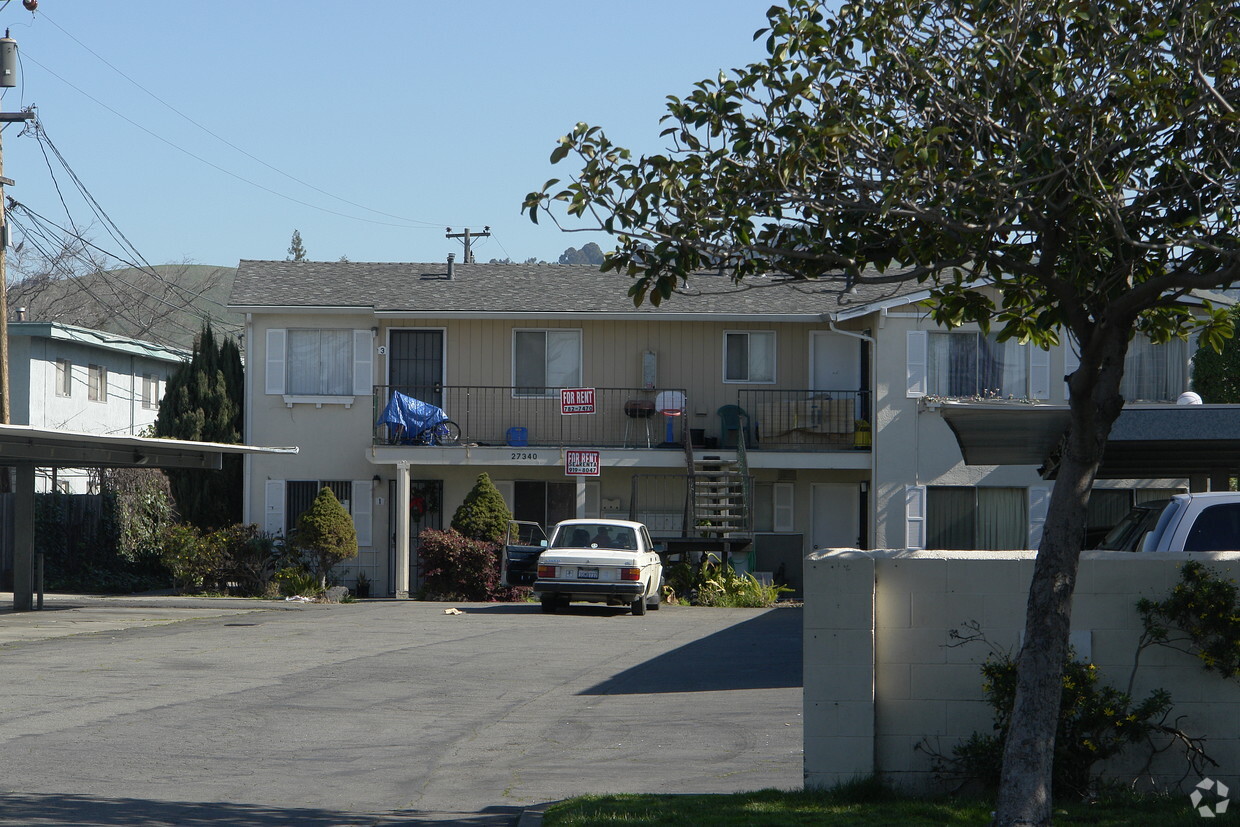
[[0, 425, 298, 611]]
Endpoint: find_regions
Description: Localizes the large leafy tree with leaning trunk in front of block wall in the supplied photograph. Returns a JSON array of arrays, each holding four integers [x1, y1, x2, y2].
[[525, 0, 1240, 825]]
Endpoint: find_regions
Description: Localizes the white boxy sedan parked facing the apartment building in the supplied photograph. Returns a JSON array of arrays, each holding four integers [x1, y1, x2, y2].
[[533, 520, 663, 615]]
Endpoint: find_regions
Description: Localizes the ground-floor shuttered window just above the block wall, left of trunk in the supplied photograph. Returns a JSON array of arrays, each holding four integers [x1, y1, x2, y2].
[[926, 485, 1029, 551]]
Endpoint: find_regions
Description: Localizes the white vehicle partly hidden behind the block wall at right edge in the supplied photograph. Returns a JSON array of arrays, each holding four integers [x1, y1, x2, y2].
[[1097, 491, 1240, 552]]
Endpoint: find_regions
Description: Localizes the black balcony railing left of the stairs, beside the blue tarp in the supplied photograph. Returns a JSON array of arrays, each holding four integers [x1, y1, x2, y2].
[[372, 384, 686, 448]]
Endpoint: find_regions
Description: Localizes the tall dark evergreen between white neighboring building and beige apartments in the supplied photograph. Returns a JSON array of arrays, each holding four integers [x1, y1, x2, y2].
[[155, 322, 244, 531]]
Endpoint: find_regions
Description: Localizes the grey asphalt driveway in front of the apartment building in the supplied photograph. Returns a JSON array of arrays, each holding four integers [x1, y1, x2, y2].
[[0, 595, 802, 827]]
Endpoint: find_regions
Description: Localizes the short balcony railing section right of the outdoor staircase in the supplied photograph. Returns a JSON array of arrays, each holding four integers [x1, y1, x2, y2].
[[724, 389, 873, 451]]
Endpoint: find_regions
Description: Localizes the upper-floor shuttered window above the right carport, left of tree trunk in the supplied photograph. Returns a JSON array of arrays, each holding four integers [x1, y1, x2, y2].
[[926, 332, 1029, 398]]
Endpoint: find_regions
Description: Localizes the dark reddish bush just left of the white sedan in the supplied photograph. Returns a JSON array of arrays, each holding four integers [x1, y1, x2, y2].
[[418, 528, 527, 601]]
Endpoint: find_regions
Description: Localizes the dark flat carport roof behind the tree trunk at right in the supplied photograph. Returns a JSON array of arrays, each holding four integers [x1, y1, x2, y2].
[[934, 402, 1240, 491]]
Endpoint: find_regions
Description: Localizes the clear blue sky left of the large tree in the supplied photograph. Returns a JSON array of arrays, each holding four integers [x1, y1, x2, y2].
[[0, 0, 769, 265]]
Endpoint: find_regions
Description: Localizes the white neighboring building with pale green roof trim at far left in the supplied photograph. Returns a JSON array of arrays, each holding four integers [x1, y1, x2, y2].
[[9, 321, 190, 493]]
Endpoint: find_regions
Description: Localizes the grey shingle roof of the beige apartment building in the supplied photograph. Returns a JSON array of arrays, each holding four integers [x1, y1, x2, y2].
[[228, 260, 925, 316]]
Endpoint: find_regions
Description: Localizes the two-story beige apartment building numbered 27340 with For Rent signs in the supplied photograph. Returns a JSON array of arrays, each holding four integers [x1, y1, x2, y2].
[[229, 260, 1188, 595]]
